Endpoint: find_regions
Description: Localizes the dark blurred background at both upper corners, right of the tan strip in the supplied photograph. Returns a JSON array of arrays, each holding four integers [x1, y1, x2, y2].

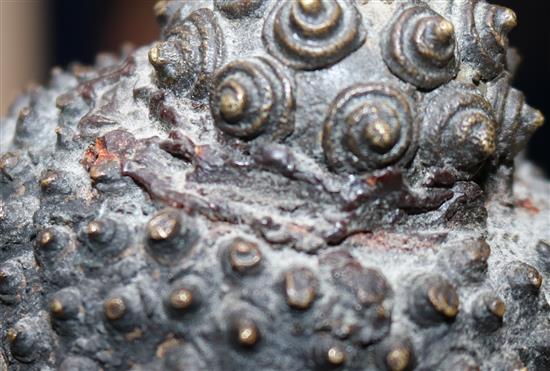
[[48, 0, 550, 175]]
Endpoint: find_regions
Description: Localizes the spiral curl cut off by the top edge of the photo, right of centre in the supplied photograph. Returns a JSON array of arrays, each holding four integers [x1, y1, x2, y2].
[[263, 0, 366, 70]]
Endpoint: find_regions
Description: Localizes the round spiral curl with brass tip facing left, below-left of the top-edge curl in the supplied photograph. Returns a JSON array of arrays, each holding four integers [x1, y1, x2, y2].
[[210, 57, 294, 139]]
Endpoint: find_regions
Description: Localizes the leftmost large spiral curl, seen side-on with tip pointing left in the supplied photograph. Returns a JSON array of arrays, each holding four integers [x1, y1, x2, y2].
[[149, 8, 224, 99]]
